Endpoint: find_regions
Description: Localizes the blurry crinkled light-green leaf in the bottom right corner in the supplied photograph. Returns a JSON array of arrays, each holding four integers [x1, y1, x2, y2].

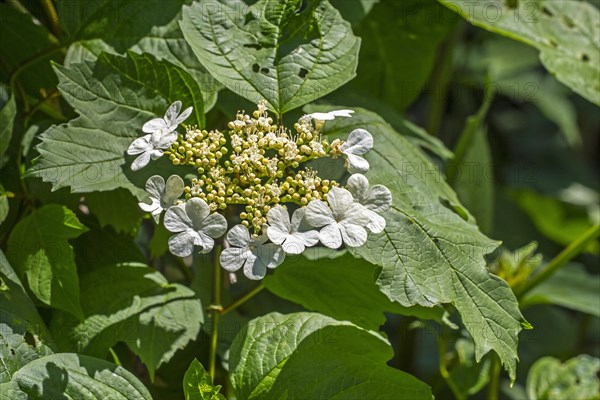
[[527, 355, 600, 400]]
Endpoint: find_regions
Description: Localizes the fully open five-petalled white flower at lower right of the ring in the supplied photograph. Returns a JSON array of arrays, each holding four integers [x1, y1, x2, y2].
[[305, 187, 371, 249]]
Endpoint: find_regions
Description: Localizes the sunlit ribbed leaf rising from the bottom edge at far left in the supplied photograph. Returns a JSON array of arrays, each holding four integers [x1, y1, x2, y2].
[[13, 353, 152, 400]]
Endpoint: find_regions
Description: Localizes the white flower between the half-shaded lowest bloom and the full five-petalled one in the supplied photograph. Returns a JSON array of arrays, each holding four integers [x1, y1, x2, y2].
[[267, 205, 319, 254]]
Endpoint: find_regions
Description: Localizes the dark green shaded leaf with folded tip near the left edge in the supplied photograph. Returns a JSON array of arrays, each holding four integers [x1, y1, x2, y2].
[[8, 204, 88, 317]]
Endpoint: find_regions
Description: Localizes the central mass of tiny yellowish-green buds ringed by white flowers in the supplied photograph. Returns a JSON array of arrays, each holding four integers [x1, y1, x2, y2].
[[165, 102, 343, 235]]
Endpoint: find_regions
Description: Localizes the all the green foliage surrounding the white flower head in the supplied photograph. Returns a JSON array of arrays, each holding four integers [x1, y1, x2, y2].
[[0, 0, 600, 400]]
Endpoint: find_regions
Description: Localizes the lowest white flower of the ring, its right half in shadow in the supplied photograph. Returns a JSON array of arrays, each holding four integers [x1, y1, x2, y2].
[[220, 225, 285, 280]]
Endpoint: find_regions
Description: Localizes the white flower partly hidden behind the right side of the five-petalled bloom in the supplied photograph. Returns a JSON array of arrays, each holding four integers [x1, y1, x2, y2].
[[346, 174, 392, 233]]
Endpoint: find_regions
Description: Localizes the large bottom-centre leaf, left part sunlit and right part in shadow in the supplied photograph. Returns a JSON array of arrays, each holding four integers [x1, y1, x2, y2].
[[229, 313, 432, 400]]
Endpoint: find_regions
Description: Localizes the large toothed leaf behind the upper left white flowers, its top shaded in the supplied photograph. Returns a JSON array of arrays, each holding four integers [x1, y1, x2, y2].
[[29, 53, 204, 196]]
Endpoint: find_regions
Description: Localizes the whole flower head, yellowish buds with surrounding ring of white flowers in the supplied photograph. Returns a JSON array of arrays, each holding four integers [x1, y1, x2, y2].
[[127, 101, 392, 279]]
